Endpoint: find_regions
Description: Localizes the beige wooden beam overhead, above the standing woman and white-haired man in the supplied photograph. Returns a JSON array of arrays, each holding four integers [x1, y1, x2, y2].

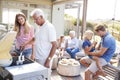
[[1, 0, 52, 10]]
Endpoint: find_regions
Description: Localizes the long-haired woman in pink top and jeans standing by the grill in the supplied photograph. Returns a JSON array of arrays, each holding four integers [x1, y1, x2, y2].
[[14, 13, 34, 59]]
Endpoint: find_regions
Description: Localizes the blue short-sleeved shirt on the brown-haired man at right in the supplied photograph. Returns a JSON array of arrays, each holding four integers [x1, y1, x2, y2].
[[101, 33, 116, 62]]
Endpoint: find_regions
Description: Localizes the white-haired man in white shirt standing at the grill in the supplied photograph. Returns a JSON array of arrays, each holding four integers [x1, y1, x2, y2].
[[31, 9, 57, 68]]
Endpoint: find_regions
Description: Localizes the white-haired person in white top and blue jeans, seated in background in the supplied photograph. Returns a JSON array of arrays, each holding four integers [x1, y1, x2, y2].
[[65, 31, 79, 58]]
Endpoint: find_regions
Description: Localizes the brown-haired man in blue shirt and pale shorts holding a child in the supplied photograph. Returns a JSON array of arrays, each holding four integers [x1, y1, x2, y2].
[[80, 25, 116, 80]]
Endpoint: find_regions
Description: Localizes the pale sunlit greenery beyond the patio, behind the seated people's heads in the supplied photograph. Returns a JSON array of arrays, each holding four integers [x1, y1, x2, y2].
[[64, 14, 120, 40]]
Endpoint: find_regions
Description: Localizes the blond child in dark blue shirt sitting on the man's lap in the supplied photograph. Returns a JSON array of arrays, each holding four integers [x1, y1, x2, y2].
[[82, 30, 105, 76]]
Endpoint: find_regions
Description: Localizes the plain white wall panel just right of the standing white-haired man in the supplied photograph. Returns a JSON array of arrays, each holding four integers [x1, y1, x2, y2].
[[52, 4, 65, 38]]
